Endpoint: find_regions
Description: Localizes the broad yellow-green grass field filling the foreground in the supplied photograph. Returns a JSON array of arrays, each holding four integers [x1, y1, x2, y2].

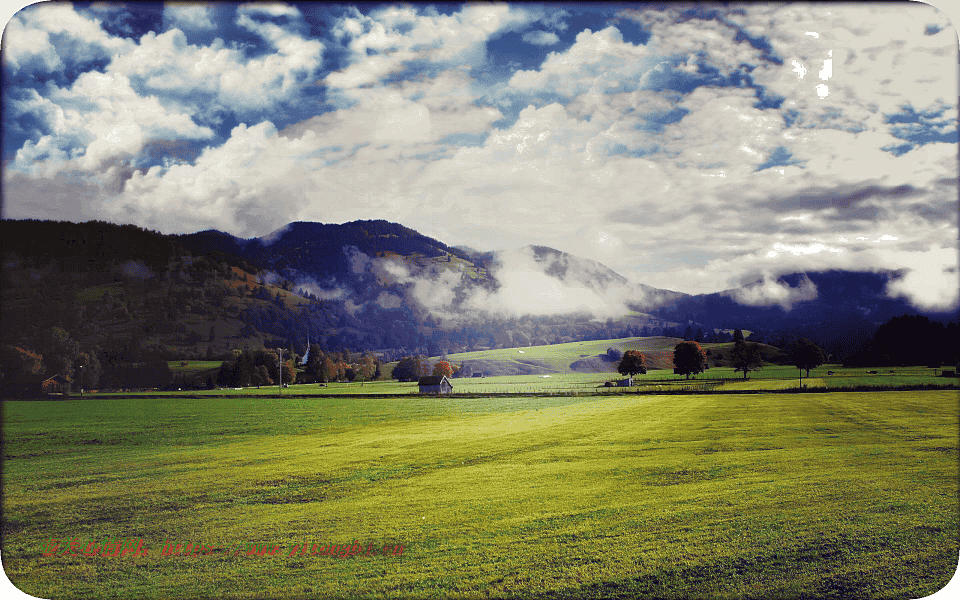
[[2, 391, 960, 598]]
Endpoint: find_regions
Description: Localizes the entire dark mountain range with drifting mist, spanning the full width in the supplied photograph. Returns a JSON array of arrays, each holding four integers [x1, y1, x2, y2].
[[0, 220, 957, 359]]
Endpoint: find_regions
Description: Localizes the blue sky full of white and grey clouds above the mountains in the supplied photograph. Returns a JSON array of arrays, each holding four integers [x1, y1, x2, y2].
[[2, 2, 960, 310]]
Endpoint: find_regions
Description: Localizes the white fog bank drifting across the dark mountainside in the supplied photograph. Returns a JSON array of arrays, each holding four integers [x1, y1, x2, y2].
[[268, 238, 682, 322]]
